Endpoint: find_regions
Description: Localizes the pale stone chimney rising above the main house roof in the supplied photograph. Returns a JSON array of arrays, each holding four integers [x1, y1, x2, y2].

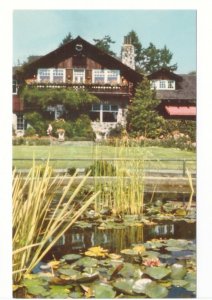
[[121, 36, 135, 70]]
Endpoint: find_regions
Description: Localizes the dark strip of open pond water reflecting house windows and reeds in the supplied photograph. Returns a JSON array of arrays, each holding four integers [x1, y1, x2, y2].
[[45, 221, 196, 259]]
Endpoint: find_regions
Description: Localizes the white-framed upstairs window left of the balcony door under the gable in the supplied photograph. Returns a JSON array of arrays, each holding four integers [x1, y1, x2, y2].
[[37, 68, 65, 83]]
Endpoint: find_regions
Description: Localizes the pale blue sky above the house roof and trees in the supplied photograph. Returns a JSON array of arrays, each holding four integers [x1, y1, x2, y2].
[[13, 9, 196, 73]]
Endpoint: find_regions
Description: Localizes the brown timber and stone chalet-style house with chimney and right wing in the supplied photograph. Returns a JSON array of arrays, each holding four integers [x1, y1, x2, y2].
[[13, 37, 196, 138]]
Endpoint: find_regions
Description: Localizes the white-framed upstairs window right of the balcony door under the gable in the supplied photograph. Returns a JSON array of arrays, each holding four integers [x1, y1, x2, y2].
[[92, 69, 120, 84]]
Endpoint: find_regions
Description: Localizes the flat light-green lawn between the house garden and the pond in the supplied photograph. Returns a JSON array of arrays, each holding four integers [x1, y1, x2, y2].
[[13, 142, 196, 170]]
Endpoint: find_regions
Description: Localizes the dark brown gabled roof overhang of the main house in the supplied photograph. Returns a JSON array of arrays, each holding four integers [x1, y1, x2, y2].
[[22, 36, 143, 82]]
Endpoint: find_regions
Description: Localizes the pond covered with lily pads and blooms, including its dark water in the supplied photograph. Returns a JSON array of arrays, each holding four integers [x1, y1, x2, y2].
[[14, 196, 196, 298]]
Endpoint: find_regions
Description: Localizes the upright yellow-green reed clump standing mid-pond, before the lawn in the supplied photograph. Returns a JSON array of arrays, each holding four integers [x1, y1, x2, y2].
[[94, 142, 144, 215]]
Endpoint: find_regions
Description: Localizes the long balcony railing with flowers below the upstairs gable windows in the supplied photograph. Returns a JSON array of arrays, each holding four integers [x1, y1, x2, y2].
[[28, 83, 132, 95]]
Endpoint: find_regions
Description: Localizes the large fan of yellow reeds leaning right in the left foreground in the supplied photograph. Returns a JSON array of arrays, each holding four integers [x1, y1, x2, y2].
[[12, 163, 98, 283]]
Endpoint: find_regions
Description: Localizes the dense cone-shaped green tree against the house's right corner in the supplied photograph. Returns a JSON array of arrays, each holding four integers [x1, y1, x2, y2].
[[127, 78, 164, 138]]
